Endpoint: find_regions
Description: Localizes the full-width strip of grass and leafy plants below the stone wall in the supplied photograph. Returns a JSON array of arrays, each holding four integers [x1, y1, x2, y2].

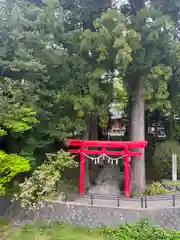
[[0, 220, 180, 240]]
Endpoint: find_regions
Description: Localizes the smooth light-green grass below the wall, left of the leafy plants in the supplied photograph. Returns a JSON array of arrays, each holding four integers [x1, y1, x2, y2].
[[0, 224, 104, 240]]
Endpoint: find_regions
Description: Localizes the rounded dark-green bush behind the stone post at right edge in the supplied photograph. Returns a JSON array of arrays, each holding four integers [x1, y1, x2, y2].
[[153, 141, 180, 179]]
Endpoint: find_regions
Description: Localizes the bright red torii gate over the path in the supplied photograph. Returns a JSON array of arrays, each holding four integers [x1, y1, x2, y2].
[[65, 139, 147, 197]]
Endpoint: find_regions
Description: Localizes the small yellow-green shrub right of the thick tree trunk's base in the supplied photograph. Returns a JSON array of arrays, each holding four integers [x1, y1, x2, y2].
[[146, 182, 173, 195]]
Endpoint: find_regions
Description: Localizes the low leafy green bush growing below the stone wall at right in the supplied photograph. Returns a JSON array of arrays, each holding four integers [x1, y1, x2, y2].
[[102, 221, 180, 240]]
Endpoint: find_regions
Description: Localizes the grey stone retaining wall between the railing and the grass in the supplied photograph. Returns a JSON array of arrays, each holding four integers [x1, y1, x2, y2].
[[0, 202, 180, 229]]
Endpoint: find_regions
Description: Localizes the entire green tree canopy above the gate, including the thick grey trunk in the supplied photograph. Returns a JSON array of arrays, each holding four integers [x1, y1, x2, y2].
[[0, 0, 180, 196]]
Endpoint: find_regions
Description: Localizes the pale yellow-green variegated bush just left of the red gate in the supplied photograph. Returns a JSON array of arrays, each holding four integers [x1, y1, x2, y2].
[[14, 151, 78, 210]]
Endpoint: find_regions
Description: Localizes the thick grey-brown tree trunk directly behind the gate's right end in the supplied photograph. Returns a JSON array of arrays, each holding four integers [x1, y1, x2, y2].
[[130, 79, 145, 193]]
